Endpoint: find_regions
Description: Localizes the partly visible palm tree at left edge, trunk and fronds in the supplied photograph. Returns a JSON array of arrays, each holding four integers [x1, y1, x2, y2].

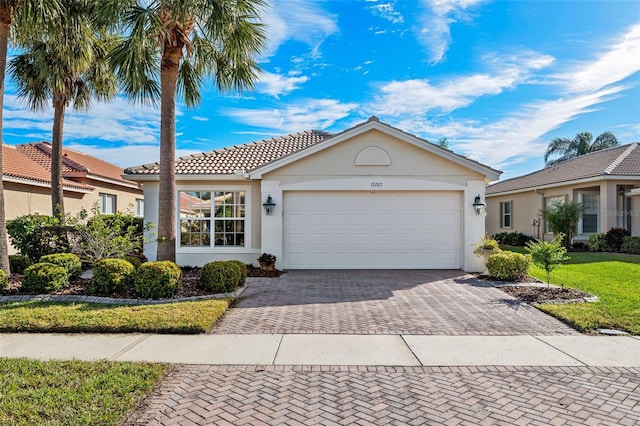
[[0, 0, 60, 274]]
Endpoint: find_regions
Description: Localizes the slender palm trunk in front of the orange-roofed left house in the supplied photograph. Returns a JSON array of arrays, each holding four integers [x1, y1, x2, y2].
[[51, 95, 66, 221]]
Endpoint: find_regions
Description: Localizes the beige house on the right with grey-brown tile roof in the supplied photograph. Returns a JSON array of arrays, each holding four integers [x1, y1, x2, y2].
[[486, 143, 640, 241]]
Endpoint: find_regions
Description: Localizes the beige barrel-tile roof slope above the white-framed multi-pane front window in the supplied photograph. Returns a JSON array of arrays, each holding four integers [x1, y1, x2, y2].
[[125, 130, 333, 175]]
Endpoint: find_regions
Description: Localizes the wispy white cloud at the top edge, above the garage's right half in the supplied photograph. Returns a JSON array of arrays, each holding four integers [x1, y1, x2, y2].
[[418, 0, 485, 64]]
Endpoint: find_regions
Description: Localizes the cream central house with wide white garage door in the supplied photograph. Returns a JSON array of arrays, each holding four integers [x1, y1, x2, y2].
[[125, 117, 501, 271]]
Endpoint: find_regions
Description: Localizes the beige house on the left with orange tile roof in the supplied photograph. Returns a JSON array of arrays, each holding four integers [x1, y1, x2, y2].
[[2, 142, 144, 228]]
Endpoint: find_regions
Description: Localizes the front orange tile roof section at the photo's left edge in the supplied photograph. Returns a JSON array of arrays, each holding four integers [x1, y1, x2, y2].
[[2, 144, 93, 190]]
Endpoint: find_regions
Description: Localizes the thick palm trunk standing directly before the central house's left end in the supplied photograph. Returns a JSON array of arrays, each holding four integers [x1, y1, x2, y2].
[[157, 43, 183, 262]]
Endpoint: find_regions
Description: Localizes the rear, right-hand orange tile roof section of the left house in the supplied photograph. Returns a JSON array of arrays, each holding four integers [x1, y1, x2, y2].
[[16, 142, 136, 187]]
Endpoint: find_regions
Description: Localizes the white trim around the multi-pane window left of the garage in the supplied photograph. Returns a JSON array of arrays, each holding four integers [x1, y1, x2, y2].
[[176, 184, 255, 254]]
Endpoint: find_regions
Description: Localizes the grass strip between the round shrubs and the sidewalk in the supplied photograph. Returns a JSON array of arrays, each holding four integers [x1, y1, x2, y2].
[[0, 299, 231, 334]]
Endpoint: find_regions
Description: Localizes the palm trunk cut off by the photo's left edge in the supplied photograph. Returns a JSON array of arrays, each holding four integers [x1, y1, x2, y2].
[[0, 12, 11, 275]]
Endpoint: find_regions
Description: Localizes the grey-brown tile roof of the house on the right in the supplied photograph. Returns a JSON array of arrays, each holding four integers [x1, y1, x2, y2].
[[486, 142, 640, 195]]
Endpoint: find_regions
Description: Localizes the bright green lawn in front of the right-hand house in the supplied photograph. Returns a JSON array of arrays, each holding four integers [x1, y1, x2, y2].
[[509, 247, 640, 335]]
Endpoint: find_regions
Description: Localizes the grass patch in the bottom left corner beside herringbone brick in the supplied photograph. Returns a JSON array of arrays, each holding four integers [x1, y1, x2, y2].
[[0, 358, 169, 426]]
